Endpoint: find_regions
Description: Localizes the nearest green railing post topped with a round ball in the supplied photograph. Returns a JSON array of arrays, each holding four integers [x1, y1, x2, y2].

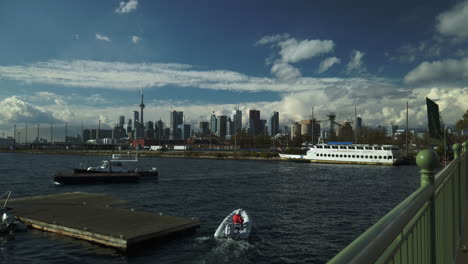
[[416, 149, 440, 264]]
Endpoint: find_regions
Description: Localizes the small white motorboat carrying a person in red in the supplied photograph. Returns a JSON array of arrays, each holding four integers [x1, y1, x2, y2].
[[214, 208, 252, 240]]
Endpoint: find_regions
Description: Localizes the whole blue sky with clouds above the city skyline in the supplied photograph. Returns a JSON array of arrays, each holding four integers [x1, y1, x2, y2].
[[0, 0, 468, 138]]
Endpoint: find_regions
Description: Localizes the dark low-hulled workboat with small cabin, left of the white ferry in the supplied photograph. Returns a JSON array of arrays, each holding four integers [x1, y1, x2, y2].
[[54, 154, 158, 184]]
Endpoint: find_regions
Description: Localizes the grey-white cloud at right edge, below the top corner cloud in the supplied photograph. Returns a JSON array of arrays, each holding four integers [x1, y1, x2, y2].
[[404, 58, 468, 84]]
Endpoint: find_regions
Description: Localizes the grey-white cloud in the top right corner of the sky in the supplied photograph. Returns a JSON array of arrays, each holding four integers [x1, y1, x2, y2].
[[436, 1, 468, 39]]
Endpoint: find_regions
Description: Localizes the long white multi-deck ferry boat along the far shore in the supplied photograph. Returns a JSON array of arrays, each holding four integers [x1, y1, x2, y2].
[[279, 142, 400, 165]]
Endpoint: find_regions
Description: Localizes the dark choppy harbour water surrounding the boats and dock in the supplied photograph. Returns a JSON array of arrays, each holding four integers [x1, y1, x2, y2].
[[0, 153, 419, 263]]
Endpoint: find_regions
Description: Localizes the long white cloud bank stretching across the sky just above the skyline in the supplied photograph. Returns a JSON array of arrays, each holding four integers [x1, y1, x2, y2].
[[0, 60, 468, 127]]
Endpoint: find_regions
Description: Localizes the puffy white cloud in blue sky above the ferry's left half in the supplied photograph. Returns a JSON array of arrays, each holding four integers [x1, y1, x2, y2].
[[278, 38, 335, 63]]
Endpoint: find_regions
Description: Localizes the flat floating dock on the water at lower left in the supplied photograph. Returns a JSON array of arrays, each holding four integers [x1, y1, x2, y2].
[[8, 192, 200, 251]]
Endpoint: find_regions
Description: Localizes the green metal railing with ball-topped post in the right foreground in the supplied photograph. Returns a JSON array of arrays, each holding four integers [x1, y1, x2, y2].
[[328, 141, 468, 264]]
